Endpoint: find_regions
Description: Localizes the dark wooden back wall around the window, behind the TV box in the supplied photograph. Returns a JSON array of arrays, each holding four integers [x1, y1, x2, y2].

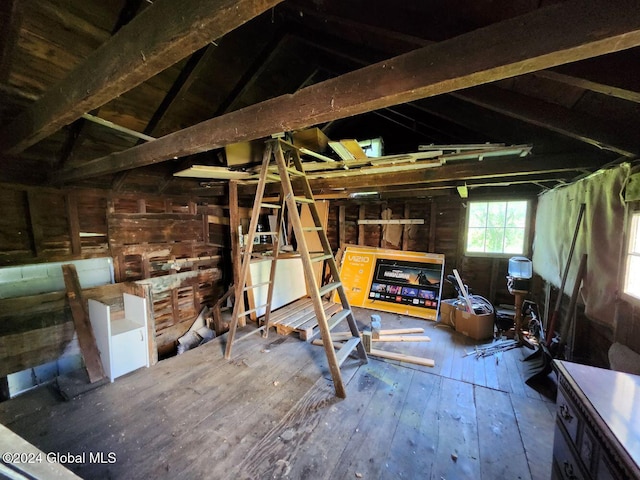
[[327, 193, 640, 368]]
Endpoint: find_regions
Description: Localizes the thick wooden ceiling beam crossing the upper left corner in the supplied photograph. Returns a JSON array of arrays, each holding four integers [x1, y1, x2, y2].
[[0, 0, 281, 154]]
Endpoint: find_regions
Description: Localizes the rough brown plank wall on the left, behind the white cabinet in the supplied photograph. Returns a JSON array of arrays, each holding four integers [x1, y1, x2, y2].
[[0, 184, 228, 364]]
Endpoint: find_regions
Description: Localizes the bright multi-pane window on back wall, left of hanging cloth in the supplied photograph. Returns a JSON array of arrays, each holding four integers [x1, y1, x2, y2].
[[465, 200, 529, 255]]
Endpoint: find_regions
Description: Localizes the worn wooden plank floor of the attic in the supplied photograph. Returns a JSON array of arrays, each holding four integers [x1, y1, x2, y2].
[[0, 310, 555, 480]]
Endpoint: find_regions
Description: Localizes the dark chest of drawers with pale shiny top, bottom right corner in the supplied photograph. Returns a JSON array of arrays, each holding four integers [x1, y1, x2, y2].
[[552, 361, 640, 480]]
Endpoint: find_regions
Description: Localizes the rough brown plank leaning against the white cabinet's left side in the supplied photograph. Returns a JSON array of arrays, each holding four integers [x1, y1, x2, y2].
[[62, 264, 104, 383]]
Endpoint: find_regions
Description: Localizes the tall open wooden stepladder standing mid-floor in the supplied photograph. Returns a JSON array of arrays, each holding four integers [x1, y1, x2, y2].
[[225, 139, 367, 398]]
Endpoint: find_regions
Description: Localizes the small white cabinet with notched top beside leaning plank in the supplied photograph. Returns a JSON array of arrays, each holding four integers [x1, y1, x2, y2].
[[89, 293, 149, 382]]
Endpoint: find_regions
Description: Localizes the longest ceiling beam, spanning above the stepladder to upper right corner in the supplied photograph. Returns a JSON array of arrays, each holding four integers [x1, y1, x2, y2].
[[56, 0, 640, 182]]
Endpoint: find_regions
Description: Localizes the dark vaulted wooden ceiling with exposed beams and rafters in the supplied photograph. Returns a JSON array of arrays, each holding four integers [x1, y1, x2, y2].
[[0, 0, 640, 201]]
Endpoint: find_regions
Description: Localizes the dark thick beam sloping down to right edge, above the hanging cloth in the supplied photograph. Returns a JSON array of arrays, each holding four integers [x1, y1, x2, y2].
[[452, 86, 640, 157]]
